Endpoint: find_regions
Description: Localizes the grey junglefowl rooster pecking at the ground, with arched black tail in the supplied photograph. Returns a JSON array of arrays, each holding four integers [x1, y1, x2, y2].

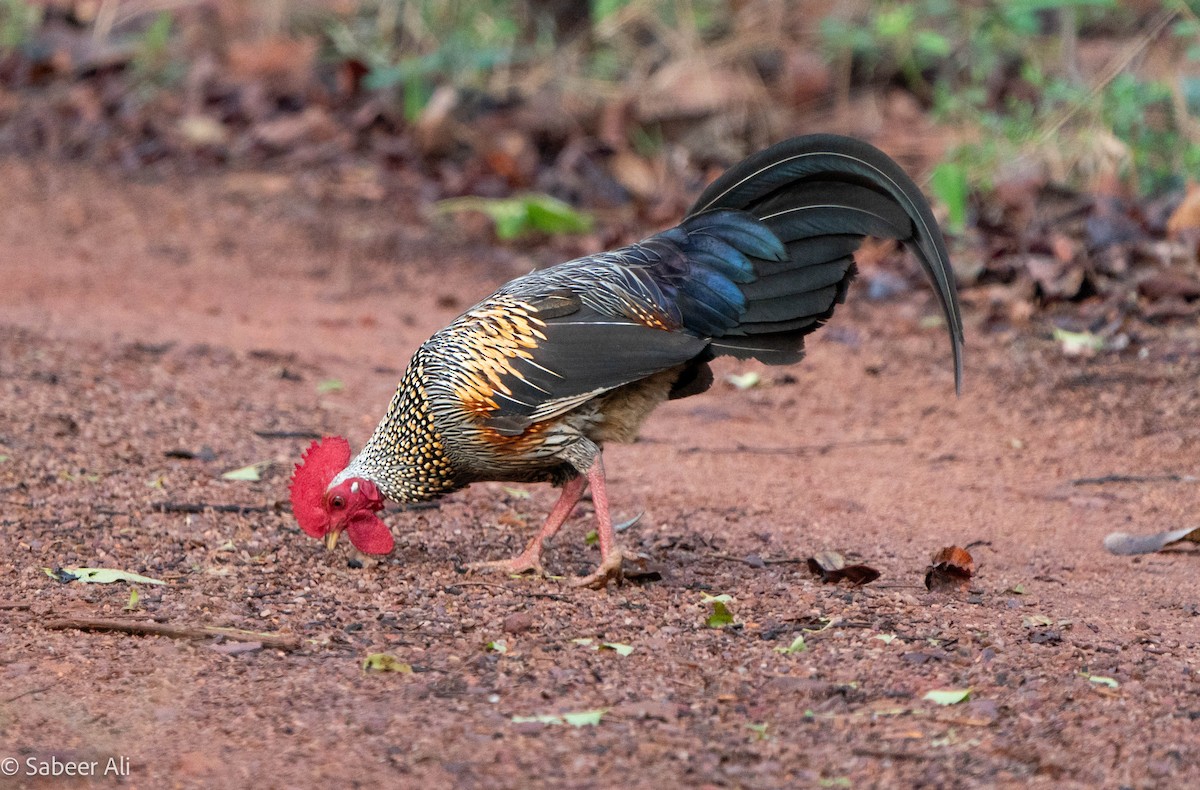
[[290, 134, 962, 587]]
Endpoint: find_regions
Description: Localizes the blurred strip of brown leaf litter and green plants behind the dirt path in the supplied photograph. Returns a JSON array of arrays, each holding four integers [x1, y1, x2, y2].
[[0, 0, 1200, 324]]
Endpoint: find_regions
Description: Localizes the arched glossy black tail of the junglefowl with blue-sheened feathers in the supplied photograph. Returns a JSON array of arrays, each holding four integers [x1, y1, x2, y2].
[[662, 134, 962, 389]]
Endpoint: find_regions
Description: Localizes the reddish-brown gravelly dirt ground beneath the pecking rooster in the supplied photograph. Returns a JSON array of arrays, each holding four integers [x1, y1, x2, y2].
[[0, 154, 1200, 788]]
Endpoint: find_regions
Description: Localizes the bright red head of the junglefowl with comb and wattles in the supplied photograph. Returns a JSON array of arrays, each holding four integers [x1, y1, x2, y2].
[[290, 436, 395, 555]]
